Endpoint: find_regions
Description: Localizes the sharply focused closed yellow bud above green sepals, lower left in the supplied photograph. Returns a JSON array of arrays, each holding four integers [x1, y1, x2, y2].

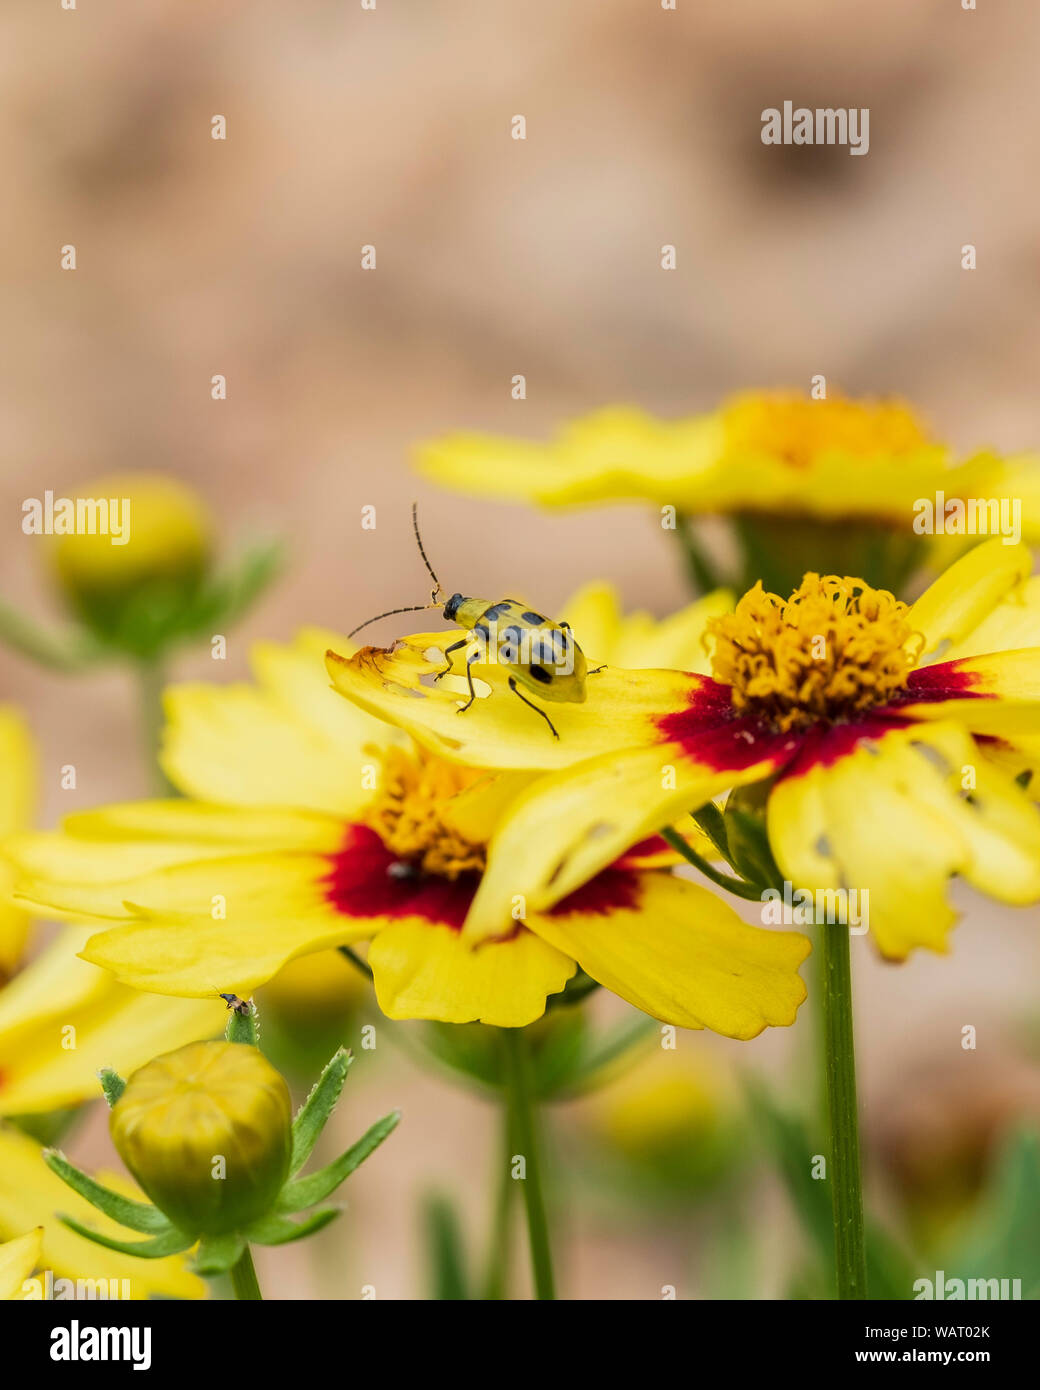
[[110, 1043, 292, 1236]]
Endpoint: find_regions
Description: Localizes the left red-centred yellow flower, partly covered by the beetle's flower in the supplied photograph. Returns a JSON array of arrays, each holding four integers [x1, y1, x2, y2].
[[15, 591, 808, 1038]]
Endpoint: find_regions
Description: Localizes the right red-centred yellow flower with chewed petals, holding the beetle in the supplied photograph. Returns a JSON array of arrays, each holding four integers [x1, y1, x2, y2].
[[322, 541, 1040, 974]]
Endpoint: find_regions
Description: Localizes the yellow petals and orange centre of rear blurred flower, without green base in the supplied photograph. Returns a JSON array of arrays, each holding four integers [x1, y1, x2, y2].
[[417, 392, 1040, 527]]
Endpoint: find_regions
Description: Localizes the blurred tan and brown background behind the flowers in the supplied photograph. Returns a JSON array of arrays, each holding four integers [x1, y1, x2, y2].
[[0, 0, 1040, 1298]]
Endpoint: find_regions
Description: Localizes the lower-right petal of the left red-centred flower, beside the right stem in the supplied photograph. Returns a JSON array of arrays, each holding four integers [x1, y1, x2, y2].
[[522, 873, 809, 1038]]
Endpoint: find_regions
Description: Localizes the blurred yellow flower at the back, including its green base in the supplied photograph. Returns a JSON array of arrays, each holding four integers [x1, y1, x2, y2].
[[417, 392, 1040, 591]]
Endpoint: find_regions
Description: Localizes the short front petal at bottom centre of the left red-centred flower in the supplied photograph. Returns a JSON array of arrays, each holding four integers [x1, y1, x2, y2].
[[368, 920, 576, 1029]]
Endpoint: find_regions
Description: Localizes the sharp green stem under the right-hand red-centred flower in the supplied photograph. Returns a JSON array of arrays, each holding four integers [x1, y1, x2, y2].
[[819, 923, 866, 1298]]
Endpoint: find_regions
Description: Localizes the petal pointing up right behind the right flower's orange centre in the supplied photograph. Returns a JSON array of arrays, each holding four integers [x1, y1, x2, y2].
[[909, 538, 1033, 662]]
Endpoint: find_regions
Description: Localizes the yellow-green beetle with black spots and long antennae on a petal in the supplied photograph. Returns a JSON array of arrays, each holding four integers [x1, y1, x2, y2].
[[348, 502, 603, 738]]
